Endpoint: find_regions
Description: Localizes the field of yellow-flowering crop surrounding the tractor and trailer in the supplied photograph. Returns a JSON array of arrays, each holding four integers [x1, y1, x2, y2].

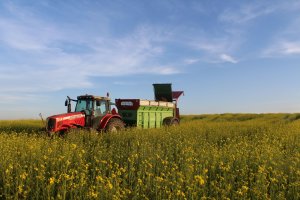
[[0, 114, 300, 199]]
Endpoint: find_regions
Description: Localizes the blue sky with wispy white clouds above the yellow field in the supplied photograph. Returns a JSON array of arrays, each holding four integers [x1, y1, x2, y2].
[[0, 0, 300, 119]]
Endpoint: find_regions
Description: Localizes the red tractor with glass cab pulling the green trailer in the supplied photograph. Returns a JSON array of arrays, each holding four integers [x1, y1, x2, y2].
[[46, 95, 124, 135]]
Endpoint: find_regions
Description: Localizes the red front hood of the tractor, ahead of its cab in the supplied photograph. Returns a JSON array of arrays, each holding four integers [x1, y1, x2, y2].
[[46, 112, 85, 132]]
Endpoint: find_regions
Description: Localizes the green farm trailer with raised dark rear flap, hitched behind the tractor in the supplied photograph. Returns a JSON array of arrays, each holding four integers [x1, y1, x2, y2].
[[116, 84, 183, 128]]
